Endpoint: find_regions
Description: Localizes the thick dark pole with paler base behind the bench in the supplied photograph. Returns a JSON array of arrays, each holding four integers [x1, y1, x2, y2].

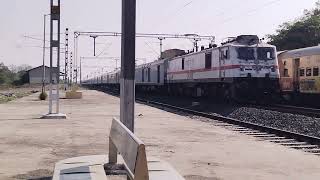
[[120, 0, 136, 132]]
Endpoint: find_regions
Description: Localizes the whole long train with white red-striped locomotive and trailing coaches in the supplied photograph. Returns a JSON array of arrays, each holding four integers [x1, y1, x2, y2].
[[84, 35, 279, 100]]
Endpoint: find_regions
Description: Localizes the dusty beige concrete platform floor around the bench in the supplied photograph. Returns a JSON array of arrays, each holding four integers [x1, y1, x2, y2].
[[0, 90, 320, 180]]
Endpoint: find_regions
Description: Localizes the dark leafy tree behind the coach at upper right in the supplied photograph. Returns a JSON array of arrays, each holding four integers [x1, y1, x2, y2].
[[268, 0, 320, 51]]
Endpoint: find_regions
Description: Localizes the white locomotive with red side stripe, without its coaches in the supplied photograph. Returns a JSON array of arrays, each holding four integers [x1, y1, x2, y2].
[[167, 35, 279, 99]]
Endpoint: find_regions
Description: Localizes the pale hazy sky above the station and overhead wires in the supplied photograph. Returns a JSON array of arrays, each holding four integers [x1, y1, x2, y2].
[[0, 0, 317, 76]]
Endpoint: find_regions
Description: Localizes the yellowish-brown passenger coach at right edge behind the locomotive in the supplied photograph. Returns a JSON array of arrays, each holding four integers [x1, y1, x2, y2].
[[278, 46, 320, 101]]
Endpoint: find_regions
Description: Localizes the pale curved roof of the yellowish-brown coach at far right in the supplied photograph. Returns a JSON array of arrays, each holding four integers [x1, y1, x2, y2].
[[279, 46, 320, 59]]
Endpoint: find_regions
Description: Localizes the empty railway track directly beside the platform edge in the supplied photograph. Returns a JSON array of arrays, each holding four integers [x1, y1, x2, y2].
[[136, 98, 320, 156]]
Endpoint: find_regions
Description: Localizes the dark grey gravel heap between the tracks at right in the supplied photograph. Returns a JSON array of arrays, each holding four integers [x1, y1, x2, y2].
[[229, 107, 320, 137]]
